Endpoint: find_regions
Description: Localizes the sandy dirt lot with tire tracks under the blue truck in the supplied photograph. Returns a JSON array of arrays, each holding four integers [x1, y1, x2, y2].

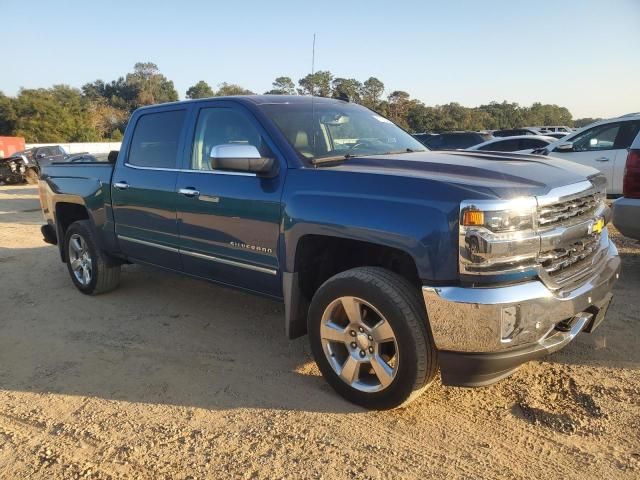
[[0, 186, 640, 480]]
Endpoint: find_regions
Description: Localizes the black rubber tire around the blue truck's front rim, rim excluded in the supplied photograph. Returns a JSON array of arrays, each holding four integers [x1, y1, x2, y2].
[[308, 267, 438, 409]]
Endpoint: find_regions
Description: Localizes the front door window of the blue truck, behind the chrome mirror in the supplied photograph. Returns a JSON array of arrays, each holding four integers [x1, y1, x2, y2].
[[191, 107, 267, 170]]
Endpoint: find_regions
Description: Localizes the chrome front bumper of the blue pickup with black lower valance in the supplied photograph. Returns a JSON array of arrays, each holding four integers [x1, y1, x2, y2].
[[422, 243, 620, 386]]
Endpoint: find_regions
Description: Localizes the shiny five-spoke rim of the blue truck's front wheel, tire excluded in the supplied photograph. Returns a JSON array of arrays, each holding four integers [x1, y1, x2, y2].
[[320, 297, 398, 393]]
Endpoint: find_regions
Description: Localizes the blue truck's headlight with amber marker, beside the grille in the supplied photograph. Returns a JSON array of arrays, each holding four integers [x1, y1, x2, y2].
[[459, 197, 540, 274]]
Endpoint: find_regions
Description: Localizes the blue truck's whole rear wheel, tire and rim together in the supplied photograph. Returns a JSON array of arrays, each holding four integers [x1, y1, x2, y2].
[[64, 220, 120, 295]]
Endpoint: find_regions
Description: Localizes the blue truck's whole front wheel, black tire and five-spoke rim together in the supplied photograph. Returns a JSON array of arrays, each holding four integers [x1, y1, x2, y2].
[[308, 267, 438, 409]]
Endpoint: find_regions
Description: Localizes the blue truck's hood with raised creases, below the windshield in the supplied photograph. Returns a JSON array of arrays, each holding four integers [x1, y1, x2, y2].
[[321, 151, 599, 198]]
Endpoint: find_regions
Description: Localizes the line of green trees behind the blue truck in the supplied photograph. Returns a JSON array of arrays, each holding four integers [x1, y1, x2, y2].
[[0, 62, 595, 143]]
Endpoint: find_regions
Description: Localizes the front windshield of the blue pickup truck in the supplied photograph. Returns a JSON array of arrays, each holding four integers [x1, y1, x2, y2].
[[261, 101, 426, 162]]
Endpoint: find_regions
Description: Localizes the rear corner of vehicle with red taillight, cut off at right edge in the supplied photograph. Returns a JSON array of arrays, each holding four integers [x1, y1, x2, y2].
[[613, 134, 640, 240]]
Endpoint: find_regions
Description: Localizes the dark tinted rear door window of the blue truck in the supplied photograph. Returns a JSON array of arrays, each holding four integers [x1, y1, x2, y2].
[[128, 110, 185, 168]]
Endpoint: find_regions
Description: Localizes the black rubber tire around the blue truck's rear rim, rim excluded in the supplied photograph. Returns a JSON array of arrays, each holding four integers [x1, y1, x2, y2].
[[64, 220, 120, 295]]
